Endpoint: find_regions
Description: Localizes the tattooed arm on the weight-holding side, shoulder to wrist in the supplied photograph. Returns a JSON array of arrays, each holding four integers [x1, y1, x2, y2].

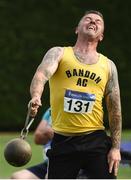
[[30, 47, 63, 98]]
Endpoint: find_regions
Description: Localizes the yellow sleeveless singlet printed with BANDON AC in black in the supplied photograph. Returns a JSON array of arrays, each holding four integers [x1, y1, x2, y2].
[[49, 47, 109, 133]]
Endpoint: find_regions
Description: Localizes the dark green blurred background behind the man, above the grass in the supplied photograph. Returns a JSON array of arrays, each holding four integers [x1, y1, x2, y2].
[[0, 0, 131, 179]]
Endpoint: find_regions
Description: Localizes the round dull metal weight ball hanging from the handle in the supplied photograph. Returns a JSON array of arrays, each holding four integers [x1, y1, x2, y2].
[[4, 138, 32, 167]]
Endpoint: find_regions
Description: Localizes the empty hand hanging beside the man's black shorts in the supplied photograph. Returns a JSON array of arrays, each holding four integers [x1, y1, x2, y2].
[[107, 148, 121, 176]]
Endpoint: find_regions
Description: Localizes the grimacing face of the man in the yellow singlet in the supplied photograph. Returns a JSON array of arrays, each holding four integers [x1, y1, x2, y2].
[[76, 13, 104, 41]]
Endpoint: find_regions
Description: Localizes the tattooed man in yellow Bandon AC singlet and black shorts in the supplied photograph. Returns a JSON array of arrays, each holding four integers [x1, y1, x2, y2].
[[29, 10, 122, 179]]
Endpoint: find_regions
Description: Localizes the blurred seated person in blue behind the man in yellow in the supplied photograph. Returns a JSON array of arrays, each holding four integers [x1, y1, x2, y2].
[[11, 108, 54, 179]]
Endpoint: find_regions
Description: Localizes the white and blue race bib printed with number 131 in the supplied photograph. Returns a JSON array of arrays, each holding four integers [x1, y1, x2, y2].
[[64, 90, 96, 113]]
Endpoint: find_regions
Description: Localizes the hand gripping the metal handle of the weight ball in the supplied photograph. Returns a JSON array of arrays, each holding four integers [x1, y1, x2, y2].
[[28, 97, 42, 117]]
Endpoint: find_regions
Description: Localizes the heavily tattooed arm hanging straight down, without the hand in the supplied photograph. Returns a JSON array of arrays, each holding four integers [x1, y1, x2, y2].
[[105, 61, 122, 149]]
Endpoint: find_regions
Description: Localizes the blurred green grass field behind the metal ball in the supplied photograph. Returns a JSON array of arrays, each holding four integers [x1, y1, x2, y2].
[[0, 130, 131, 179]]
